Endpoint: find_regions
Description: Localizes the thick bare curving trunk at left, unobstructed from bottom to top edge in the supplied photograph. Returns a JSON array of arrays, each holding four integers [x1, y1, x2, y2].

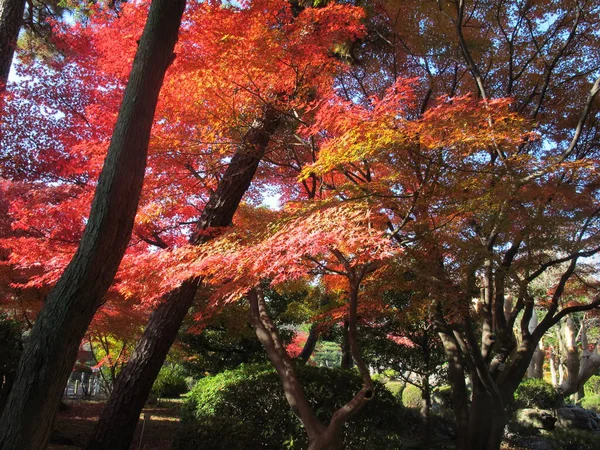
[[0, 0, 185, 450]]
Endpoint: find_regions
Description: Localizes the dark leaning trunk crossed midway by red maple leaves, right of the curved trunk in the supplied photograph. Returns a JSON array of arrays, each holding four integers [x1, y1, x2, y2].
[[86, 108, 279, 450]]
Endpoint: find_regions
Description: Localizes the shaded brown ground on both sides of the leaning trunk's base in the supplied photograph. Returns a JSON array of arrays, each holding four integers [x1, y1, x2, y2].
[[48, 400, 181, 450]]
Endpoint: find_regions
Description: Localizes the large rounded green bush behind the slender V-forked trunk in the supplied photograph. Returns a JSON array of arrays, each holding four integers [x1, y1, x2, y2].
[[174, 365, 402, 450]]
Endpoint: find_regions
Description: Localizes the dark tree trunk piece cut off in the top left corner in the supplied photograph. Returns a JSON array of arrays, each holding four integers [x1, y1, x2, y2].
[[0, 0, 25, 90]]
